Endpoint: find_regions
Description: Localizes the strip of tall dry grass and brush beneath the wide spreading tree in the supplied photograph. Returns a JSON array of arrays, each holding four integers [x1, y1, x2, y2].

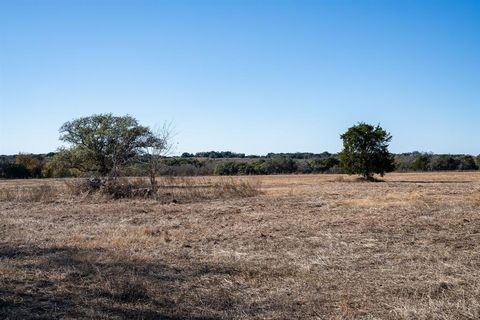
[[0, 177, 261, 202]]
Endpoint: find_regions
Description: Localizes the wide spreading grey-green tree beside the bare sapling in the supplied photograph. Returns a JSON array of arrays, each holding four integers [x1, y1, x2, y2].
[[60, 113, 155, 177]]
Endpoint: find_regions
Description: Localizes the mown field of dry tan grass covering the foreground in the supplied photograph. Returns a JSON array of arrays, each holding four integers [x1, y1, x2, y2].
[[0, 173, 480, 319]]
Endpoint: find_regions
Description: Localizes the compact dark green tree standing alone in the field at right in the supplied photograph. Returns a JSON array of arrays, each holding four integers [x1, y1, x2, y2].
[[340, 122, 395, 180]]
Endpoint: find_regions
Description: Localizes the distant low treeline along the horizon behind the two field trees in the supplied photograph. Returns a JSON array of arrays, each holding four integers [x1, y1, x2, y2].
[[0, 151, 480, 179]]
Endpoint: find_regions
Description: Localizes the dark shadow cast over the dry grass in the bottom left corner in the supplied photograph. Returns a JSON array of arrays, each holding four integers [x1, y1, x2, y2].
[[0, 244, 248, 320]]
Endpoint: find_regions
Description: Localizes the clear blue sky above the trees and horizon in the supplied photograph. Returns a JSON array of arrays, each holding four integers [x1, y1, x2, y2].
[[0, 0, 480, 154]]
